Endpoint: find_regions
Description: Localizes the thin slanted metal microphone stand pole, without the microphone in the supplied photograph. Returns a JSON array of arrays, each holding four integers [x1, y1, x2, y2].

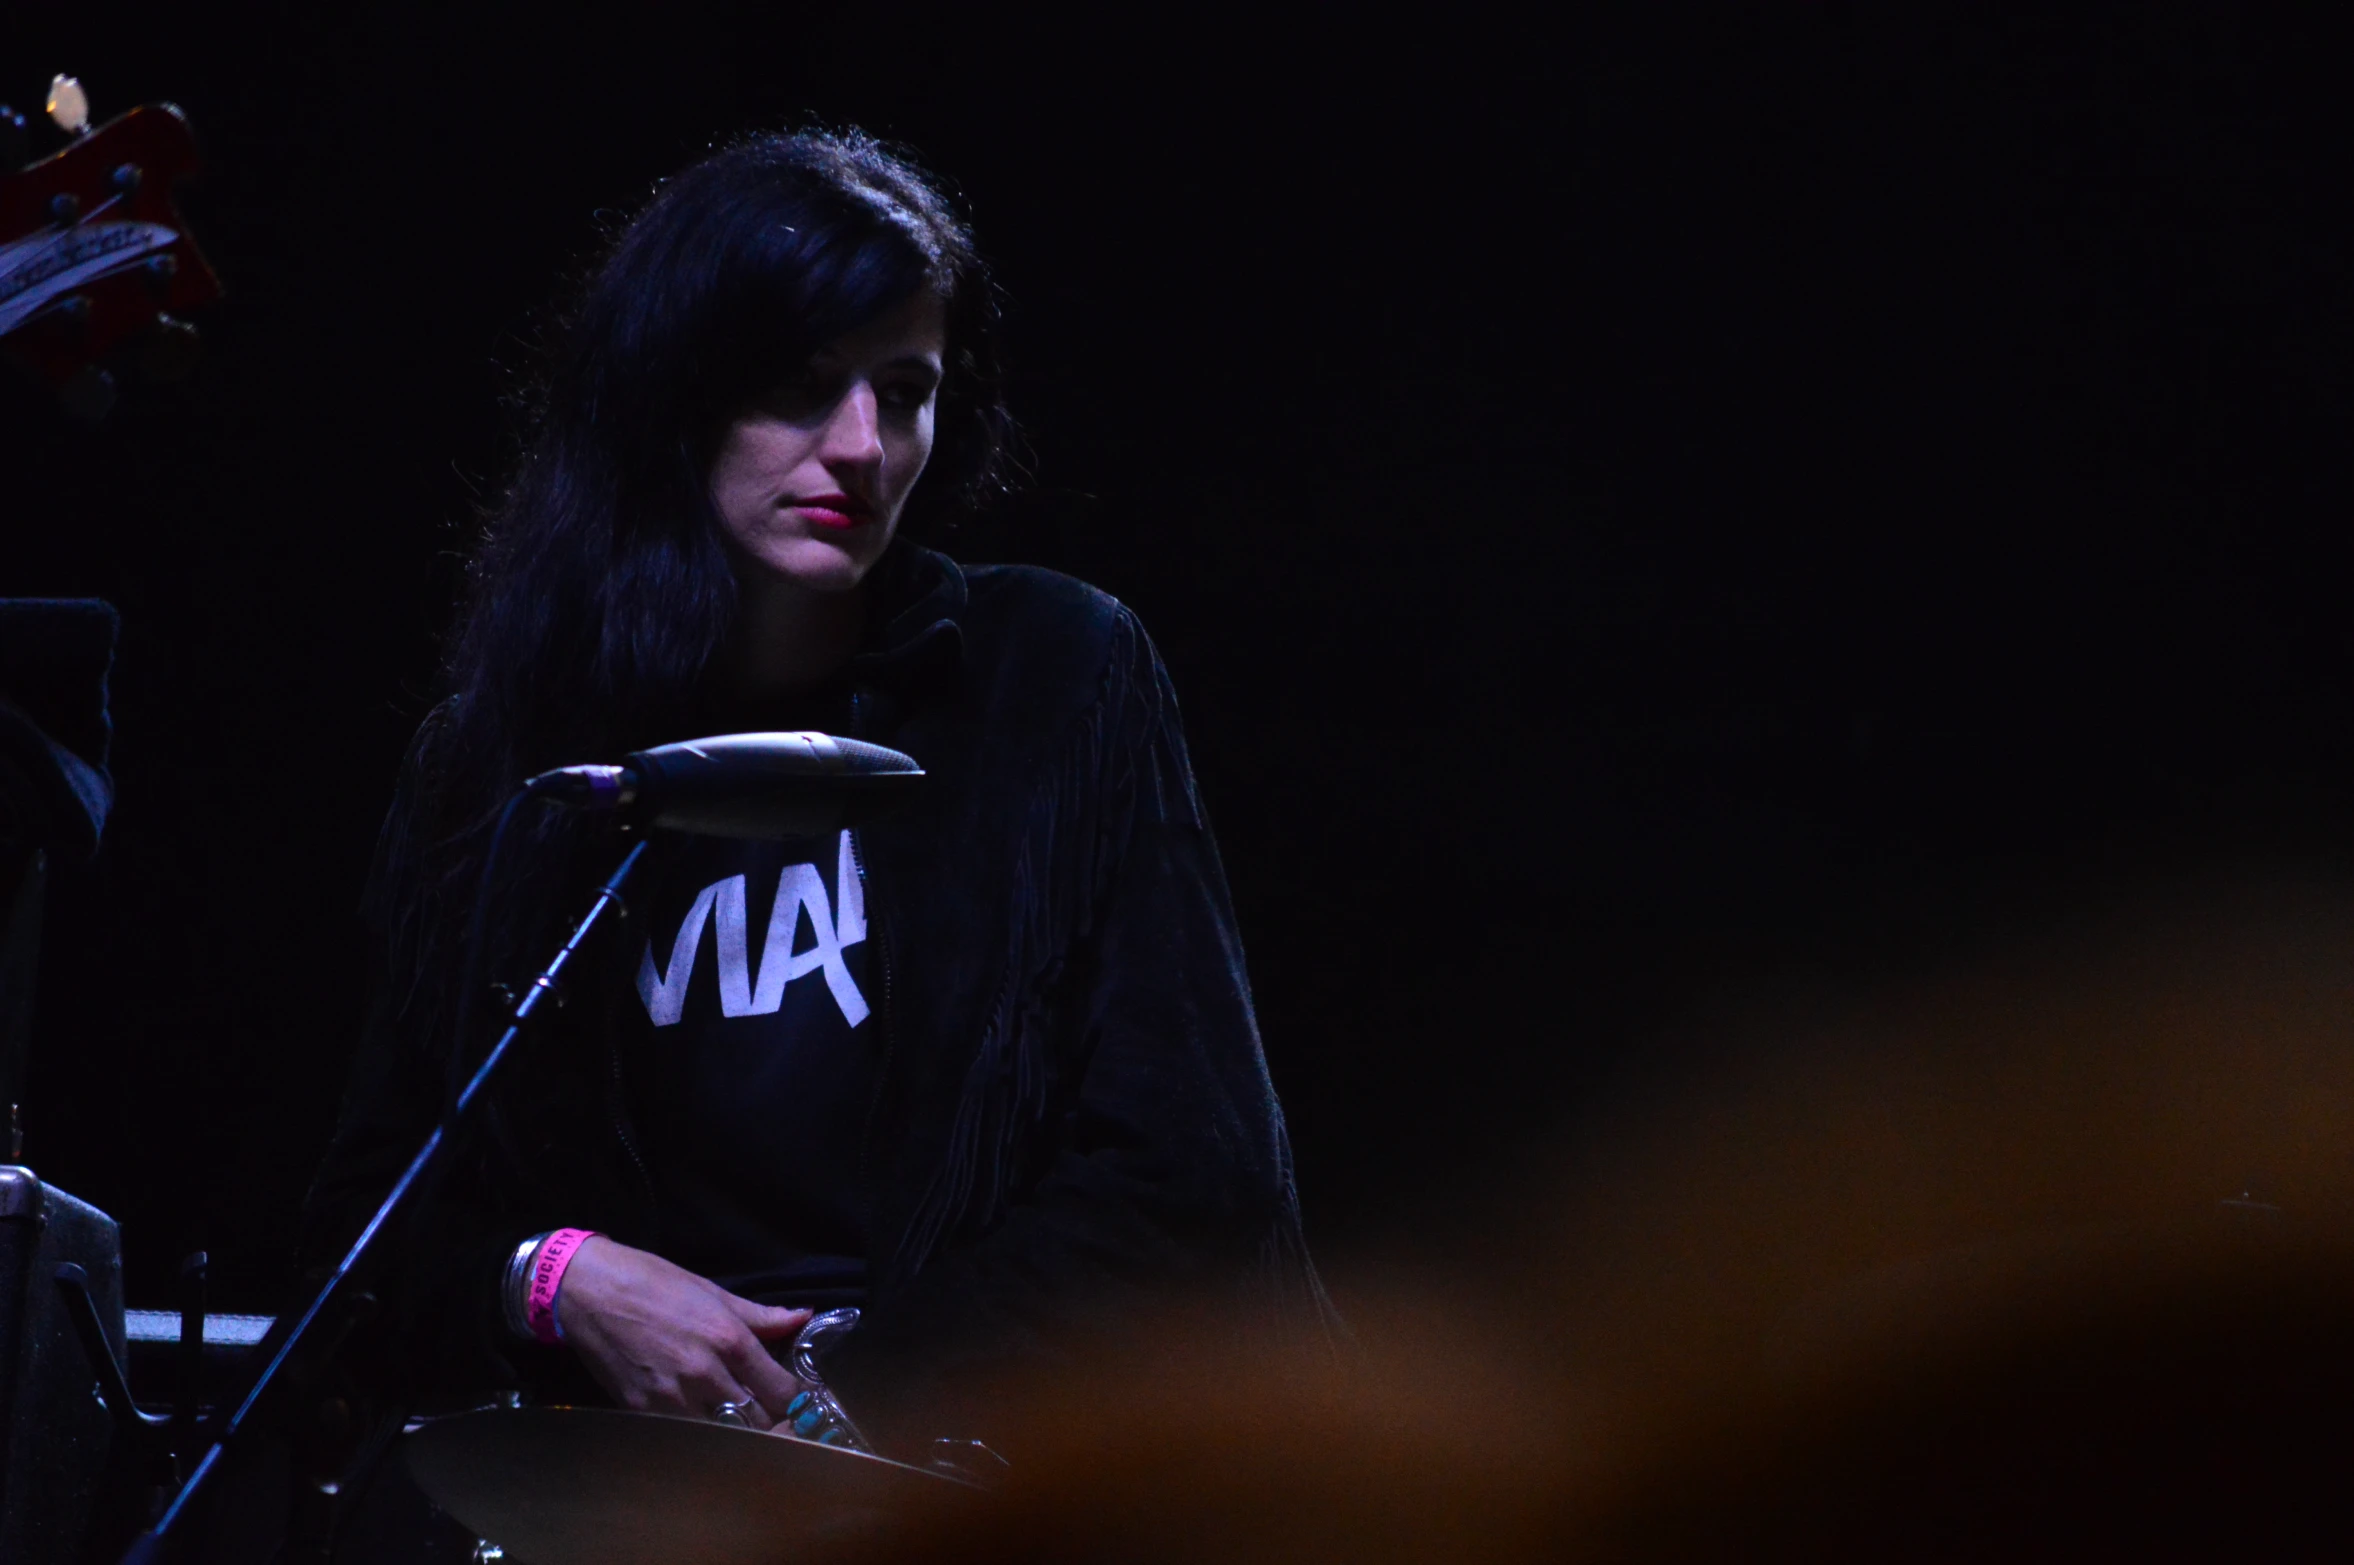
[[122, 843, 645, 1565]]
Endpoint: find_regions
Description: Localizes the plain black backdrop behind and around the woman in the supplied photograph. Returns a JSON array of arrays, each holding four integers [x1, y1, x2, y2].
[[0, 0, 2354, 1308]]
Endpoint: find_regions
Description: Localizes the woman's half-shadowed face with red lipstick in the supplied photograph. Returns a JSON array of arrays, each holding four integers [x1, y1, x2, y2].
[[711, 289, 946, 593]]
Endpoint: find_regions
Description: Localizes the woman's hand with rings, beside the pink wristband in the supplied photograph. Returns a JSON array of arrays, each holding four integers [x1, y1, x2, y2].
[[556, 1236, 810, 1429]]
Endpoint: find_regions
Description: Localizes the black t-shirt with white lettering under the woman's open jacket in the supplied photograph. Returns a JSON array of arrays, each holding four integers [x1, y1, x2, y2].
[[626, 831, 883, 1308]]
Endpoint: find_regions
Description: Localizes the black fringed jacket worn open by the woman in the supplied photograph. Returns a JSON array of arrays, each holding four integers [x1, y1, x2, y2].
[[308, 544, 1328, 1440]]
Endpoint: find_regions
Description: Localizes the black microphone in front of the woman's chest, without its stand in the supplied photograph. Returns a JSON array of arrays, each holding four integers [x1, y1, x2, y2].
[[523, 732, 923, 838]]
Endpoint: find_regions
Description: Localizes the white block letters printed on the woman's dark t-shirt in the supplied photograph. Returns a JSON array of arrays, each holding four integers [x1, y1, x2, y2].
[[638, 831, 866, 1026]]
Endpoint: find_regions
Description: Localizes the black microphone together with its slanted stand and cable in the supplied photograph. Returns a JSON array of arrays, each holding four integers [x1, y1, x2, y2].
[[122, 734, 923, 1565]]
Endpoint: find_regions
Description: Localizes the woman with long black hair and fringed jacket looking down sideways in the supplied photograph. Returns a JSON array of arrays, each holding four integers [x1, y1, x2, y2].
[[298, 134, 1325, 1445]]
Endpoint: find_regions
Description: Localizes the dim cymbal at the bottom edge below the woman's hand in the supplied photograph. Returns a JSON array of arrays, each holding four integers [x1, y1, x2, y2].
[[400, 1407, 979, 1565]]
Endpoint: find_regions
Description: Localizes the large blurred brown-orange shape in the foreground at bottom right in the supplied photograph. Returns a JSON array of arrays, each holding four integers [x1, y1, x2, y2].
[[842, 880, 2354, 1565]]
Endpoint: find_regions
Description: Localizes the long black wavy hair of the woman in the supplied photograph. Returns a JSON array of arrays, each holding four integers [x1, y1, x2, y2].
[[370, 132, 1010, 1063]]
